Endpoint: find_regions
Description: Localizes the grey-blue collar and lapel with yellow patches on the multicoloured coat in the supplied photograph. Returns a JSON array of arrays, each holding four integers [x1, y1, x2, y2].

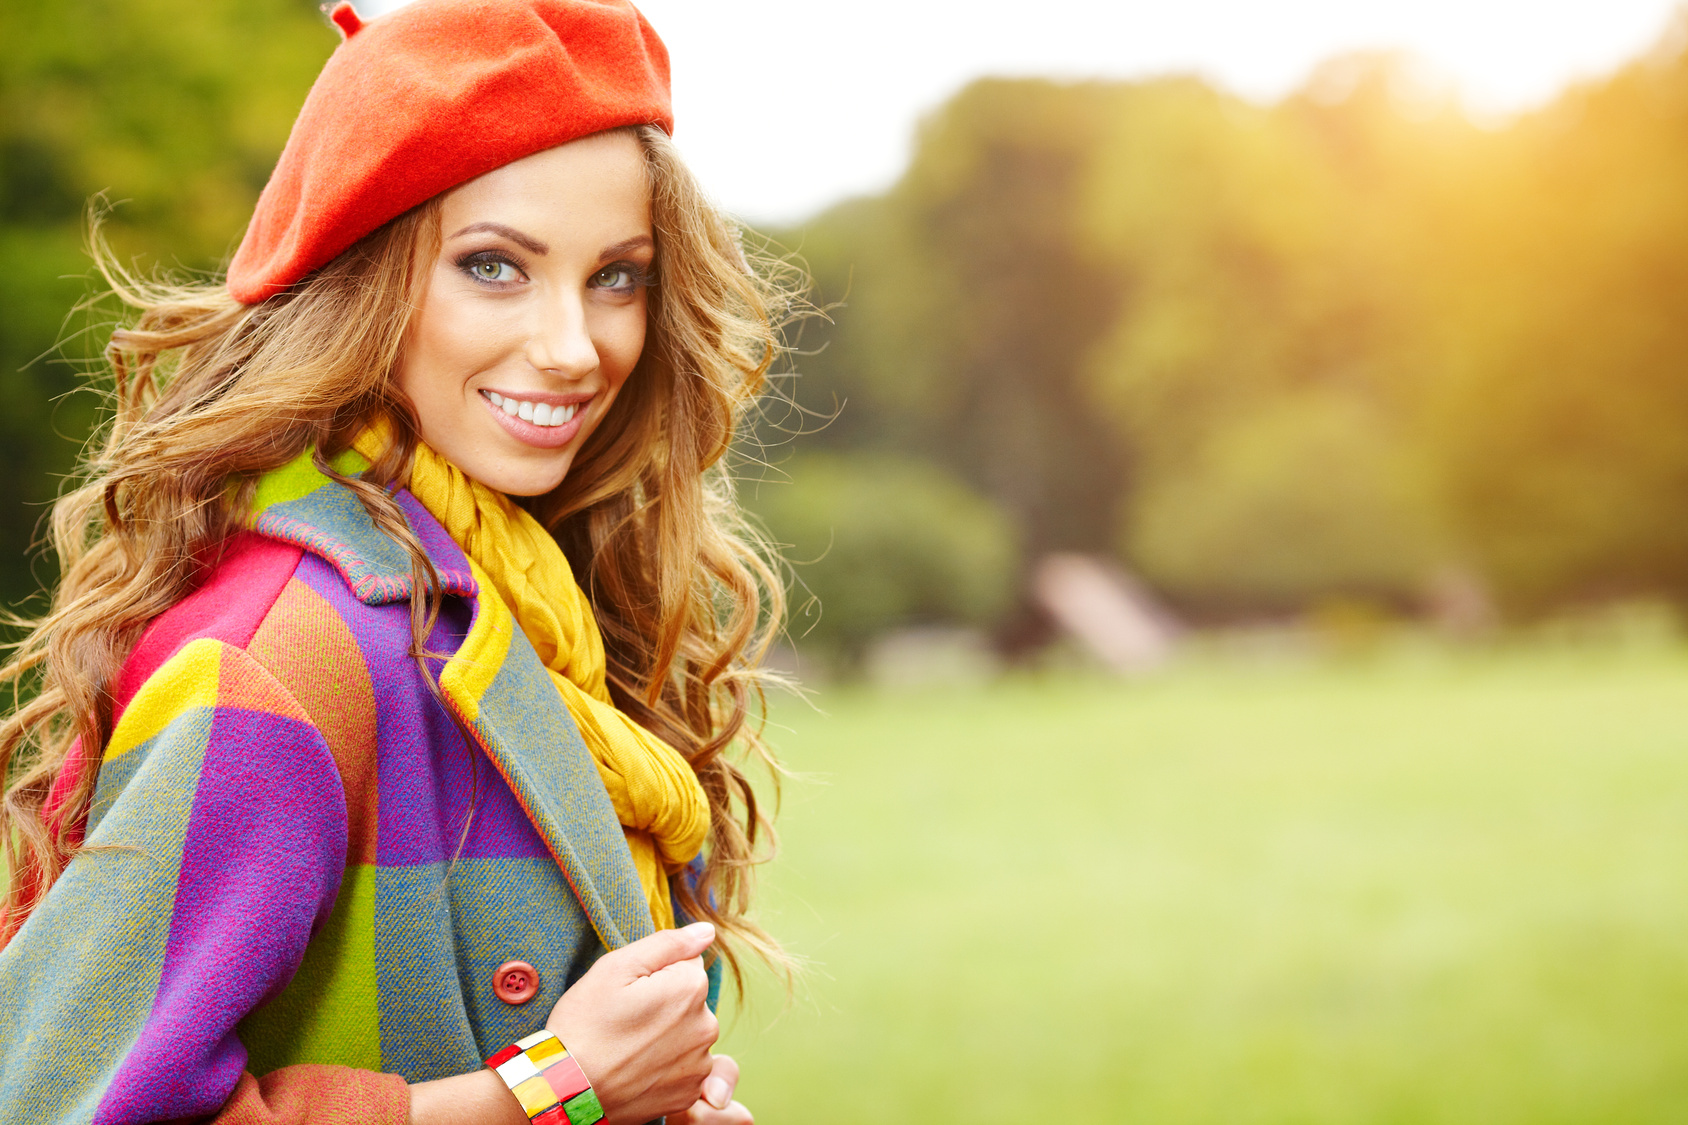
[[252, 451, 652, 949]]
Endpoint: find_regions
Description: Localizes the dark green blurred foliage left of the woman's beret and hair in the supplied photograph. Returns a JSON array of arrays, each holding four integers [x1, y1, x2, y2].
[[0, 0, 336, 605]]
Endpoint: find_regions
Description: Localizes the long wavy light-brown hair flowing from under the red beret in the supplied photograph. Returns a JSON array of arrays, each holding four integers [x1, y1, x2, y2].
[[0, 127, 795, 976]]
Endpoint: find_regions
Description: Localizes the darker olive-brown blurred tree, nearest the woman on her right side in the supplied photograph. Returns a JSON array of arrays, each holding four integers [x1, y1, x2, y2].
[[782, 81, 1124, 552]]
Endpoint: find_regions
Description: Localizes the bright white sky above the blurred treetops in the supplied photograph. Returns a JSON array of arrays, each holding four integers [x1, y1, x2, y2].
[[358, 0, 1676, 221]]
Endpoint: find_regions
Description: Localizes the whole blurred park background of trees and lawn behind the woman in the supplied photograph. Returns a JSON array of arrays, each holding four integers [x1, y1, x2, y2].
[[0, 0, 1688, 1125]]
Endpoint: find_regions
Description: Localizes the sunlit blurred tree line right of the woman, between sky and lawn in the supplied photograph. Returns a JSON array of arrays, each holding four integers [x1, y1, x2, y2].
[[785, 41, 1688, 613]]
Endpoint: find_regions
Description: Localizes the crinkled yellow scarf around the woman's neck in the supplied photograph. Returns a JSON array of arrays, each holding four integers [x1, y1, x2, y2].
[[354, 426, 709, 929]]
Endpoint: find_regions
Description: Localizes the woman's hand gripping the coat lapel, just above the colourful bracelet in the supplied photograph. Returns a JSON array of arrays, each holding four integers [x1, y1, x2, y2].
[[545, 922, 719, 1125]]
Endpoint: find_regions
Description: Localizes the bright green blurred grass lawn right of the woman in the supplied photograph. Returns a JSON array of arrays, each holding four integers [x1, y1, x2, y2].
[[724, 638, 1688, 1125]]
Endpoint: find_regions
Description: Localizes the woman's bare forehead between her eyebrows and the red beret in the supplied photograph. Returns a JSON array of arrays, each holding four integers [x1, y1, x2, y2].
[[441, 132, 650, 245]]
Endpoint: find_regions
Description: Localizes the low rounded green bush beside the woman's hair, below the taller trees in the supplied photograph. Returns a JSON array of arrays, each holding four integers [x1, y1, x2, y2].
[[744, 453, 1016, 660]]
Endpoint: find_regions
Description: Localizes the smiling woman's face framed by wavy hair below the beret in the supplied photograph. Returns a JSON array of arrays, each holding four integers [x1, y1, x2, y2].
[[398, 133, 655, 497]]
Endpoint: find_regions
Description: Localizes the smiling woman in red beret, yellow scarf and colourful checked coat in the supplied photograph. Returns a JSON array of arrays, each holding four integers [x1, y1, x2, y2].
[[0, 0, 780, 1125]]
